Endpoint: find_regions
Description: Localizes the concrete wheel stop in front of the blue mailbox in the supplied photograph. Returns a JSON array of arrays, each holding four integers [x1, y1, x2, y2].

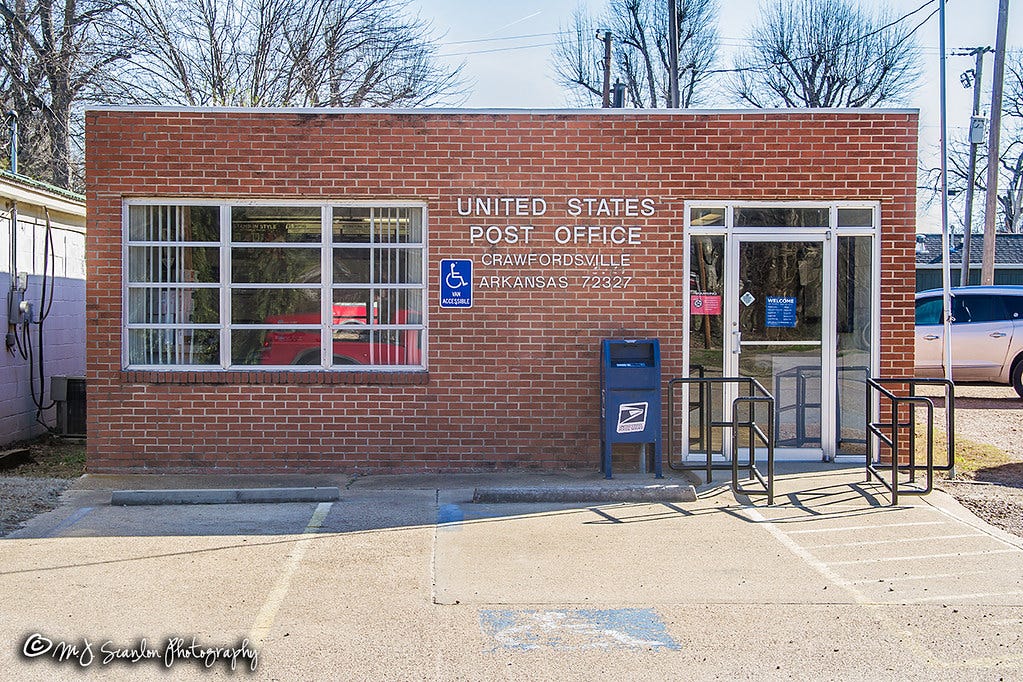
[[473, 484, 697, 503]]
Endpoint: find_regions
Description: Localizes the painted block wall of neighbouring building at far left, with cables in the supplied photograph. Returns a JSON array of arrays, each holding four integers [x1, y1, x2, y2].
[[0, 201, 86, 447]]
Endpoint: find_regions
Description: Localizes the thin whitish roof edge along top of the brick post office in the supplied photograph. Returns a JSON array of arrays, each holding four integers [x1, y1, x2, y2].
[[85, 104, 920, 117]]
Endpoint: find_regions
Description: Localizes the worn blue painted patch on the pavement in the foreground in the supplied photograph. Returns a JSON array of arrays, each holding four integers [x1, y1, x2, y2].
[[480, 608, 681, 651]]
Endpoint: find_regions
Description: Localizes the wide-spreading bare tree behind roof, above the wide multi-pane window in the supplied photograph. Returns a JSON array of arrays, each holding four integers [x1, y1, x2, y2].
[[117, 0, 460, 106]]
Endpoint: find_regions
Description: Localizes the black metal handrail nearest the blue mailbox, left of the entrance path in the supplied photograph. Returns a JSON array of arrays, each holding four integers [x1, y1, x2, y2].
[[667, 376, 774, 504]]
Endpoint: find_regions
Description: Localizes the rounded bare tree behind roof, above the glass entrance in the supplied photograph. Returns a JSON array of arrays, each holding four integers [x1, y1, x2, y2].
[[731, 0, 926, 107]]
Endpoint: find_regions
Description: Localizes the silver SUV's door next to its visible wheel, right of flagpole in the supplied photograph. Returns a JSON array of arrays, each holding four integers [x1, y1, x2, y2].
[[952, 293, 1013, 381]]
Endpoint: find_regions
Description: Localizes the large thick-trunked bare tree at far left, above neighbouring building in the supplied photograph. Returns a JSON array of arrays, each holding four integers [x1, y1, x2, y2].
[[0, 0, 128, 188]]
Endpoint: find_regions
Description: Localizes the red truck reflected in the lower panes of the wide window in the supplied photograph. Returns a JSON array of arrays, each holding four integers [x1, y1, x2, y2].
[[260, 304, 421, 366]]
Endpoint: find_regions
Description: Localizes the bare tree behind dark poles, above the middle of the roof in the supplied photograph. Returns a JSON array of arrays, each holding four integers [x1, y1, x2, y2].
[[552, 0, 717, 107]]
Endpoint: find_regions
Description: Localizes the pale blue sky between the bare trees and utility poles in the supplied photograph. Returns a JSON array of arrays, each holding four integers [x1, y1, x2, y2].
[[410, 0, 1023, 231]]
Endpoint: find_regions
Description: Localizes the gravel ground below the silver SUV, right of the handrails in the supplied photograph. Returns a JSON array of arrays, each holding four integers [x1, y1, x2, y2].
[[935, 385, 1023, 537]]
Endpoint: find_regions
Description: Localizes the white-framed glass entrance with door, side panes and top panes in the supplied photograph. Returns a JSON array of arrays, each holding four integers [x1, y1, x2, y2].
[[673, 202, 881, 460]]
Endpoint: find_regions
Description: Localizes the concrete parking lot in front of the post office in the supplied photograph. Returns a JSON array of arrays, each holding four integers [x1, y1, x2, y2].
[[0, 464, 1023, 680]]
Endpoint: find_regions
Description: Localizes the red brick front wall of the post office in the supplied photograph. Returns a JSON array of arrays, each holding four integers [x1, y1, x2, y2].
[[87, 110, 917, 471]]
